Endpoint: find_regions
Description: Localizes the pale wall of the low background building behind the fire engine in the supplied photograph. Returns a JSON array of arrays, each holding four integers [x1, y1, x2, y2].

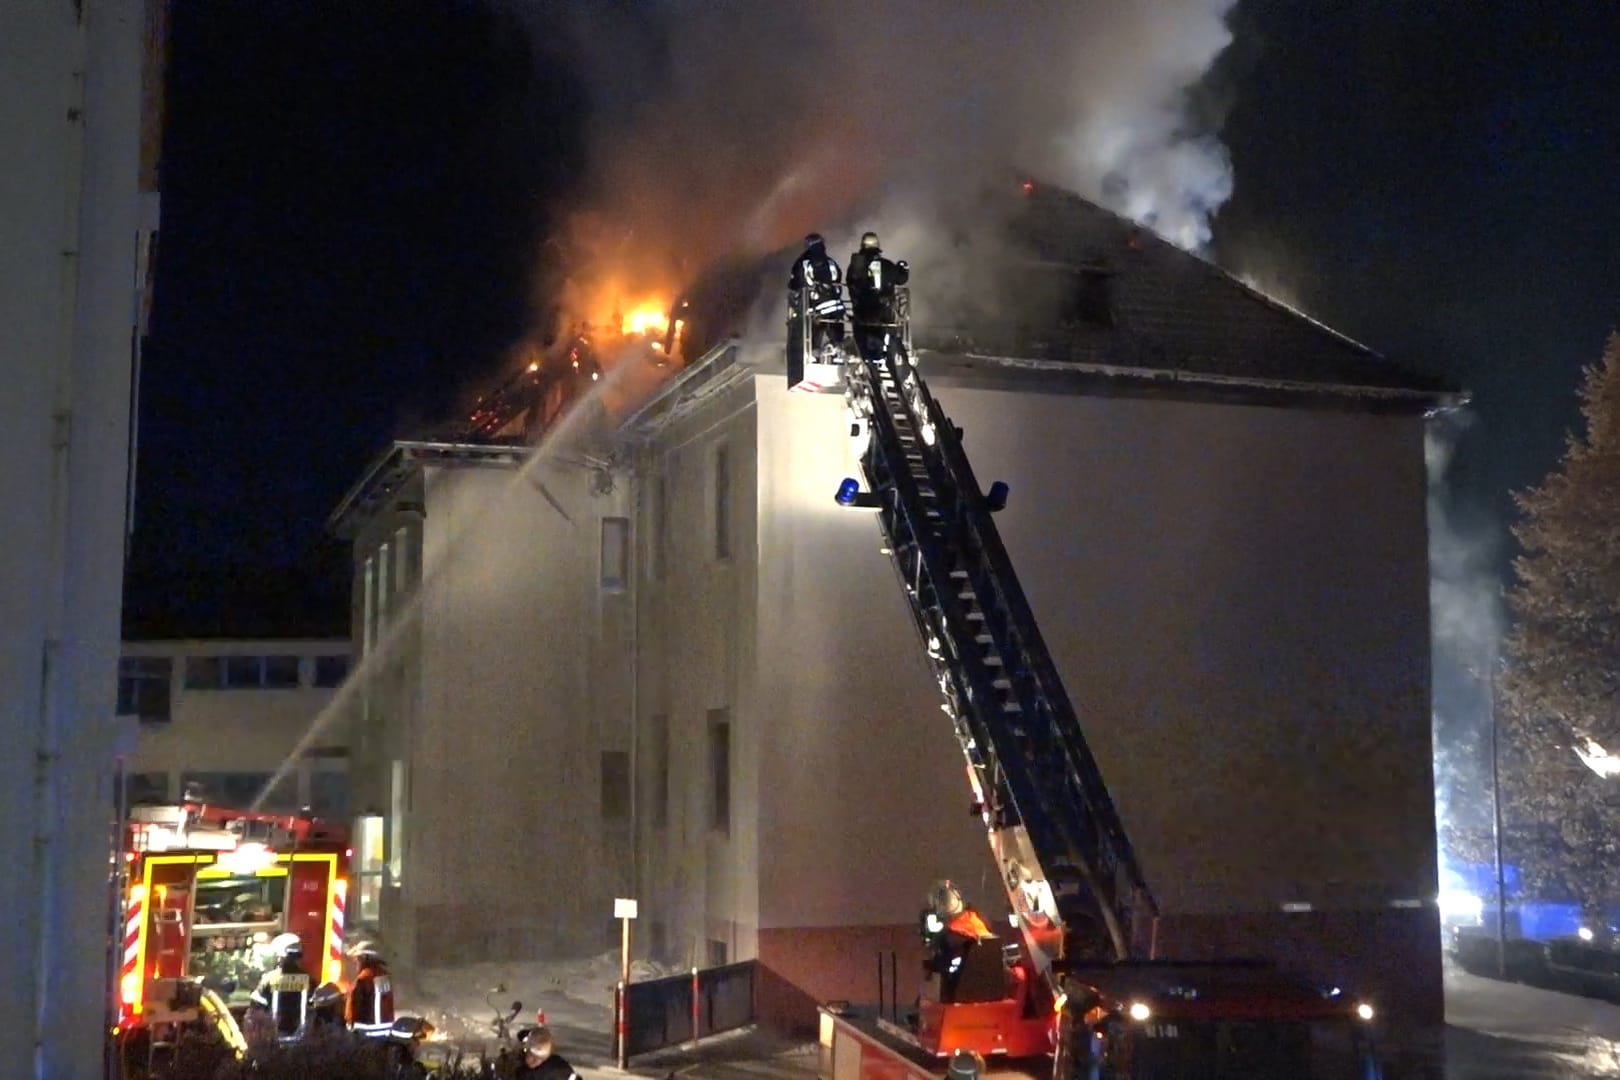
[[123, 641, 350, 805]]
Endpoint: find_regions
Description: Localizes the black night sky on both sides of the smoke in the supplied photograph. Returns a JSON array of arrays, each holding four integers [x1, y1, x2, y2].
[[125, 0, 1620, 636]]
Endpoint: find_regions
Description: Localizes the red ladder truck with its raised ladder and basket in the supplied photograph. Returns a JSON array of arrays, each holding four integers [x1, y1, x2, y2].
[[787, 275, 1380, 1080]]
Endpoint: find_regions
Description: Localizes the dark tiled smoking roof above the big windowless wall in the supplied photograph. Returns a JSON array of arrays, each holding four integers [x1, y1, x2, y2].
[[685, 181, 1468, 413]]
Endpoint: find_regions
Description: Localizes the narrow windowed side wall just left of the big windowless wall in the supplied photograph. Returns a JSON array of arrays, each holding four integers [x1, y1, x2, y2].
[[637, 385, 761, 965]]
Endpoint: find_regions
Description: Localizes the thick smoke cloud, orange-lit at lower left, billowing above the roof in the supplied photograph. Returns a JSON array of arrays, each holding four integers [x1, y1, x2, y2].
[[522, 0, 1234, 333]]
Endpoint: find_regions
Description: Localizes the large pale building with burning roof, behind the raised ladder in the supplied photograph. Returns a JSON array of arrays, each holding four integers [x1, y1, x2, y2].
[[335, 185, 1458, 1049]]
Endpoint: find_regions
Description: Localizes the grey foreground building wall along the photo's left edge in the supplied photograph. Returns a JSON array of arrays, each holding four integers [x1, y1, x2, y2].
[[0, 0, 144, 1077]]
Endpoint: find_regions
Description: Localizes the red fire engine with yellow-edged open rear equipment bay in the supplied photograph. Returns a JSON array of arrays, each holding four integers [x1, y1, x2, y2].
[[113, 803, 353, 1041]]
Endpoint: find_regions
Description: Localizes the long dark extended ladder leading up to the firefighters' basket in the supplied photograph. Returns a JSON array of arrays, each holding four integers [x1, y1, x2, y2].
[[816, 293, 1157, 976]]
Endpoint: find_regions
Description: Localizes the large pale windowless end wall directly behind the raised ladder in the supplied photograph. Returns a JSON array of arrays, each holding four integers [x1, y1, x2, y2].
[[741, 369, 1439, 1018]]
